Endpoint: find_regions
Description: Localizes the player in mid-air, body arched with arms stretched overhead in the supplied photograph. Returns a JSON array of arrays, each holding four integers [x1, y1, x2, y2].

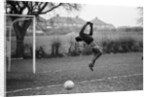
[[75, 22, 102, 71]]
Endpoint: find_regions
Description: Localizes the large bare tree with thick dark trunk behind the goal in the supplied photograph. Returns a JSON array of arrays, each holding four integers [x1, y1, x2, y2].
[[6, 0, 81, 57]]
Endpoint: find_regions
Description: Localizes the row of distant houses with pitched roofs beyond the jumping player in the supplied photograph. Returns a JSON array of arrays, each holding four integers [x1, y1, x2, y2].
[[47, 15, 115, 30]]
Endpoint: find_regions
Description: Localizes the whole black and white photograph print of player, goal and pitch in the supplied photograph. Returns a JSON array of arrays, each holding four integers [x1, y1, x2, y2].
[[4, 0, 144, 96]]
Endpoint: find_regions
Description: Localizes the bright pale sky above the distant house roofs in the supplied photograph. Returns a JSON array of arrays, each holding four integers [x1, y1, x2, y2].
[[40, 4, 139, 27]]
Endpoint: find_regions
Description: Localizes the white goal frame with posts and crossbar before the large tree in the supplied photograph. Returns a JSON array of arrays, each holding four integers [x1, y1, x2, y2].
[[5, 14, 36, 74]]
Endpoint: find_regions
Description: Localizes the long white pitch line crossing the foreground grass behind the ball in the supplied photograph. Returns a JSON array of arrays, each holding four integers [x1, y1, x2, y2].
[[6, 73, 143, 94]]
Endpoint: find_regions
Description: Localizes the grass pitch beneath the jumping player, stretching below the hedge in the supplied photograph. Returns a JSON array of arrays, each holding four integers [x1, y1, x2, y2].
[[6, 53, 143, 96]]
